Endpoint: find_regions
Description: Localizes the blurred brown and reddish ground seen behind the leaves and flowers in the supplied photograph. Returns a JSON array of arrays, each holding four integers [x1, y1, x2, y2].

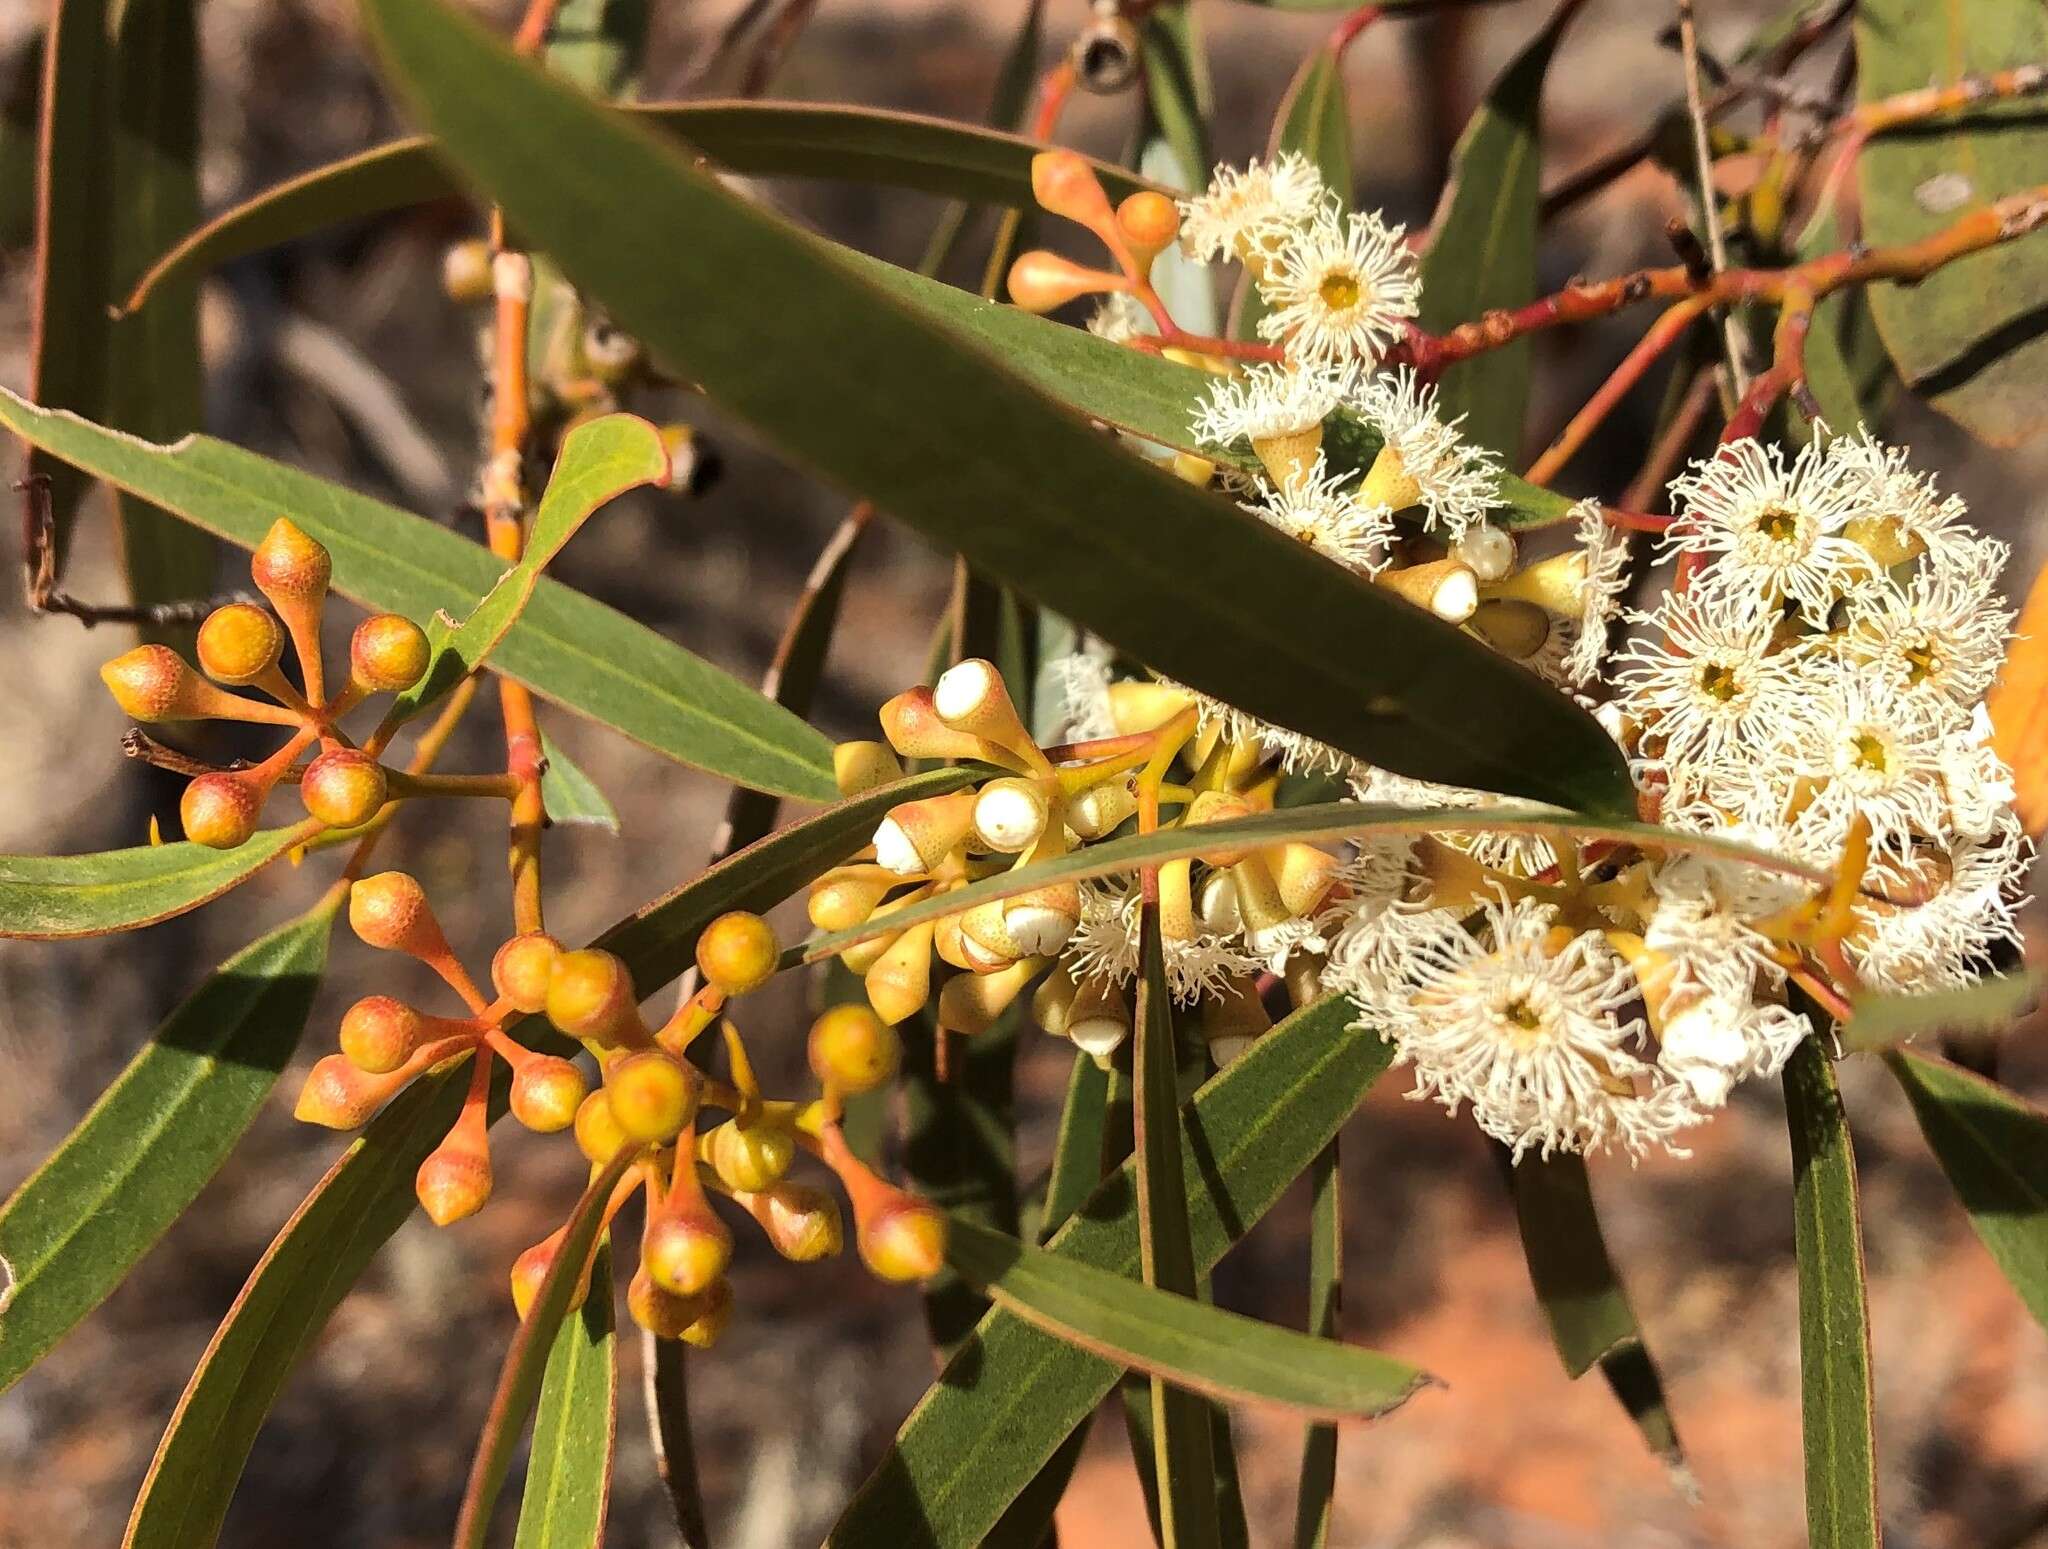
[[0, 0, 2048, 1549]]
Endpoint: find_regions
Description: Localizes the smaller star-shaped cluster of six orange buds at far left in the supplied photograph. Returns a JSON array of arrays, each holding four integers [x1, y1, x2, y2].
[[100, 518, 450, 850]]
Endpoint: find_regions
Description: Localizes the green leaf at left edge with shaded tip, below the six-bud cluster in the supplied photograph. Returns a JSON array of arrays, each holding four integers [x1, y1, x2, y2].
[[0, 895, 340, 1389]]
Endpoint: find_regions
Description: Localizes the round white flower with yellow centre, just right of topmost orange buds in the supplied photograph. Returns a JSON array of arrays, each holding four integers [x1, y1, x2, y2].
[[1257, 211, 1421, 363]]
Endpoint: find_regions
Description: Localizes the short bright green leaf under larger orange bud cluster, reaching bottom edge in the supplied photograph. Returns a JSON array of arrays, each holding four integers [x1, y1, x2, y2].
[[512, 1244, 618, 1549]]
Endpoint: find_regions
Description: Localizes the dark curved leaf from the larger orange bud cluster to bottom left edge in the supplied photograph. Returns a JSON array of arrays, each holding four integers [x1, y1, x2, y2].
[[121, 1057, 479, 1549]]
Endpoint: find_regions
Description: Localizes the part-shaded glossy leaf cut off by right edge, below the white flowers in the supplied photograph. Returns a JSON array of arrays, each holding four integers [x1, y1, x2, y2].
[[1884, 1049, 2048, 1328]]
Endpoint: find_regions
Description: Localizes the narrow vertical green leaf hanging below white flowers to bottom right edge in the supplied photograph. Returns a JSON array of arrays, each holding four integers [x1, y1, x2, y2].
[[1784, 1039, 1878, 1549]]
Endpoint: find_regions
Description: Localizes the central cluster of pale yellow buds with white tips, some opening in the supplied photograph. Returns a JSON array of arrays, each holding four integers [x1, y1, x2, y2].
[[809, 658, 1339, 1063]]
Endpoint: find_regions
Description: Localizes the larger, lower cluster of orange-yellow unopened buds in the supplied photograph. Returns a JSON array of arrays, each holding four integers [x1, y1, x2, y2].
[[297, 889, 946, 1346]]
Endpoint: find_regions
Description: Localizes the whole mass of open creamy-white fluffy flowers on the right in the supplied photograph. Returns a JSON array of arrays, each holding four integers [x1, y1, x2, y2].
[[1053, 156, 2030, 1156]]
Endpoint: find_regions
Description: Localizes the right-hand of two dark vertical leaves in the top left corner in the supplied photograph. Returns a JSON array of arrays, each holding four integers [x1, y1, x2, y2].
[[104, 0, 215, 637]]
